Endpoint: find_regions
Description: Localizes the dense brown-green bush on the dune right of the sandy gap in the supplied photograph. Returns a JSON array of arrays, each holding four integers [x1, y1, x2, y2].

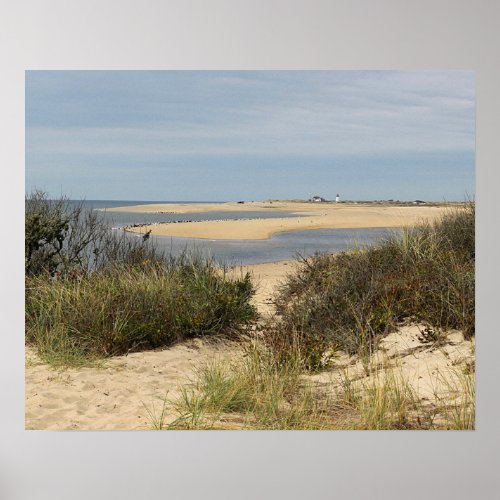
[[267, 203, 475, 368]]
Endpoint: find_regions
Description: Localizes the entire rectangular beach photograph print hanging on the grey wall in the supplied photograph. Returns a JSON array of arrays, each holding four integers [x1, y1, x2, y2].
[[25, 70, 475, 430]]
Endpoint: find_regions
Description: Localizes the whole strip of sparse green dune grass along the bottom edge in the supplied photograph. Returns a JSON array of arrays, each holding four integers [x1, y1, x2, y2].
[[148, 340, 475, 430]]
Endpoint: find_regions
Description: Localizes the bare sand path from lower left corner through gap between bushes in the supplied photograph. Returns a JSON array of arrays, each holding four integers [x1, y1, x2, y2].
[[25, 262, 293, 430]]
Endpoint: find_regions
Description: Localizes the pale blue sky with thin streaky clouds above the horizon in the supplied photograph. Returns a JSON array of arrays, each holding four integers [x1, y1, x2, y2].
[[25, 71, 475, 201]]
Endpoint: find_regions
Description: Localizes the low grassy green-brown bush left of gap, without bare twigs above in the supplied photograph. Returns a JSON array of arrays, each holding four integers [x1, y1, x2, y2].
[[26, 256, 256, 364]]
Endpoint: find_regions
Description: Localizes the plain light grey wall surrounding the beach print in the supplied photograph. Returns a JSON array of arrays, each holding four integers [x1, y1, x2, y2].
[[0, 0, 500, 500]]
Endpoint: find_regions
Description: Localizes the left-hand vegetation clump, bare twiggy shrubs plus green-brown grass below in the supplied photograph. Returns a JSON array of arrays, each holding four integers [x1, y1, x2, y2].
[[26, 193, 256, 364]]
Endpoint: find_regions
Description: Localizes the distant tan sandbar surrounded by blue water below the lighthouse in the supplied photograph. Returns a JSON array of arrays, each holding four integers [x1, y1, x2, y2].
[[119, 202, 447, 240]]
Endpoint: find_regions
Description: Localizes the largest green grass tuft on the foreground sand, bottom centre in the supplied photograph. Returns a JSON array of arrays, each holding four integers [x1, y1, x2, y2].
[[145, 342, 342, 430]]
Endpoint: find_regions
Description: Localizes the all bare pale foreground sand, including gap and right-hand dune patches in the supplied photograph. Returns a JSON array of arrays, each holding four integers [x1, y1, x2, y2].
[[25, 261, 474, 430]]
